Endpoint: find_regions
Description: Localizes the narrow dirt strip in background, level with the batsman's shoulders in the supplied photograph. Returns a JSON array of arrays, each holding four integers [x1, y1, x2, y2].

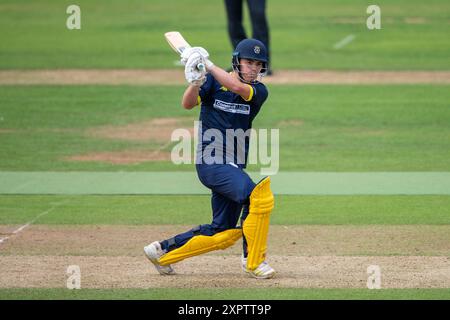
[[0, 68, 450, 85]]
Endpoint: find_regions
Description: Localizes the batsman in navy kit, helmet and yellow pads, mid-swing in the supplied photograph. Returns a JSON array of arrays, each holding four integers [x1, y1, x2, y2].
[[144, 39, 275, 279]]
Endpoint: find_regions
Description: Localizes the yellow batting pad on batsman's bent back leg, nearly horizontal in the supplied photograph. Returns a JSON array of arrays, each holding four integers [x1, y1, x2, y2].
[[159, 229, 242, 266]]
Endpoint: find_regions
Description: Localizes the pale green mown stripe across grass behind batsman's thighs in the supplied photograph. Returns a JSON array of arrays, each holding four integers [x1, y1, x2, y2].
[[0, 172, 450, 195]]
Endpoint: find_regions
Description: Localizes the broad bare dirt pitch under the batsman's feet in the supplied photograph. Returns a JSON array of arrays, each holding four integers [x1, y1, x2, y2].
[[0, 225, 450, 288]]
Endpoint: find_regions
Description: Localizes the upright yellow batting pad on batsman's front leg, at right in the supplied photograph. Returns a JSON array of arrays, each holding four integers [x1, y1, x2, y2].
[[243, 177, 274, 270]]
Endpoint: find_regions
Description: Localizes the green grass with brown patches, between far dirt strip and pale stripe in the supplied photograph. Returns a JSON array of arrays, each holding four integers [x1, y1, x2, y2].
[[0, 85, 450, 172]]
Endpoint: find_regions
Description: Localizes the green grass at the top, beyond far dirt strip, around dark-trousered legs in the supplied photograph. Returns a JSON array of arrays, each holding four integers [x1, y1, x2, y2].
[[0, 0, 450, 70]]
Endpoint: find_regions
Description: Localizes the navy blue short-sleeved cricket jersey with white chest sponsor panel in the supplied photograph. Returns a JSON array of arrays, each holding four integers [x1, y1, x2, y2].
[[196, 73, 268, 168]]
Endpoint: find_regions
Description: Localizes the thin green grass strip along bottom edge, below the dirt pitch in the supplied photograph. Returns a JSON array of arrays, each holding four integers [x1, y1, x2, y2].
[[0, 288, 450, 300]]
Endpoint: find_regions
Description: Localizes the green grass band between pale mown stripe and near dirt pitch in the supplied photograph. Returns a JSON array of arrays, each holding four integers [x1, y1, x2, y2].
[[0, 195, 450, 225]]
